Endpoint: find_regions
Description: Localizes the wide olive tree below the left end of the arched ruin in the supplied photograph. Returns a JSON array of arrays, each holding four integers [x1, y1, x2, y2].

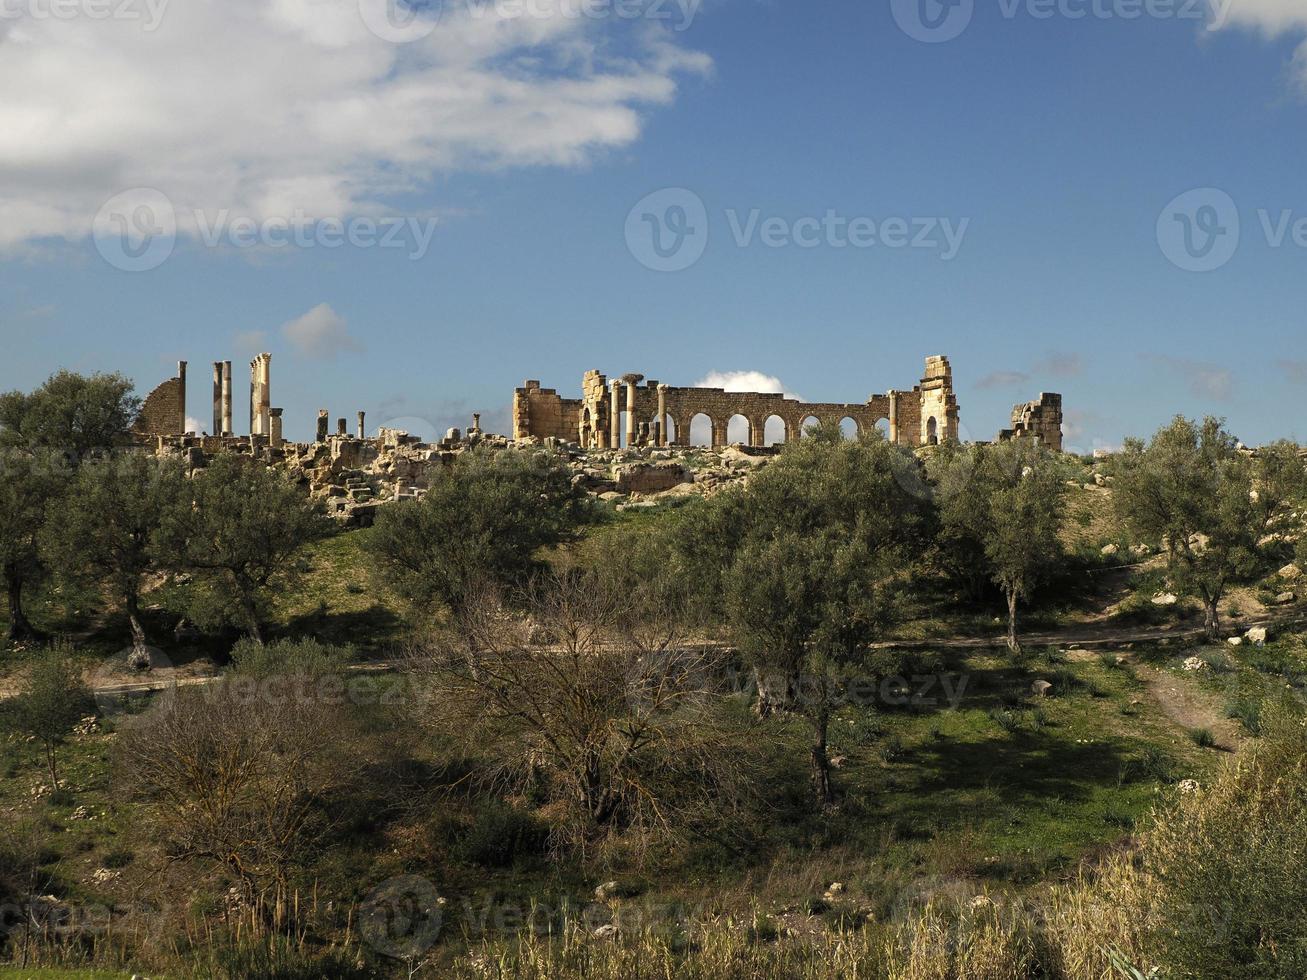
[[369, 448, 586, 610]]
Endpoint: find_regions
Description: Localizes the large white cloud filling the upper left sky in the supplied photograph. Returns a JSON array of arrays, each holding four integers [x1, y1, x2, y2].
[[0, 0, 710, 248]]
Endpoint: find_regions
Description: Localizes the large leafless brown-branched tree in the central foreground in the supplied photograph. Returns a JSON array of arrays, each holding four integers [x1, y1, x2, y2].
[[414, 568, 749, 862]]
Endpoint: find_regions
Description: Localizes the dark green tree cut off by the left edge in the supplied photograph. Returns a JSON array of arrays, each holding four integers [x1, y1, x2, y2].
[[0, 448, 68, 643]]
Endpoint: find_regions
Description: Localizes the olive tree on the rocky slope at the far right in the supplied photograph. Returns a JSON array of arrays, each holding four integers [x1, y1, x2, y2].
[[1114, 416, 1303, 640]]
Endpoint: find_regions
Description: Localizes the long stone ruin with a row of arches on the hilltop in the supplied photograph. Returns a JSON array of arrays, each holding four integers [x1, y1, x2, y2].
[[512, 357, 958, 449]]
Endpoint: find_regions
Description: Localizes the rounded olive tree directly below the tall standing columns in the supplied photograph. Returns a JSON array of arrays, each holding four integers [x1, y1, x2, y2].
[[158, 455, 328, 642]]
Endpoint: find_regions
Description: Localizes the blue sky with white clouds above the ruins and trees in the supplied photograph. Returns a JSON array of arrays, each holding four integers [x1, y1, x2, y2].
[[0, 0, 1307, 448]]
